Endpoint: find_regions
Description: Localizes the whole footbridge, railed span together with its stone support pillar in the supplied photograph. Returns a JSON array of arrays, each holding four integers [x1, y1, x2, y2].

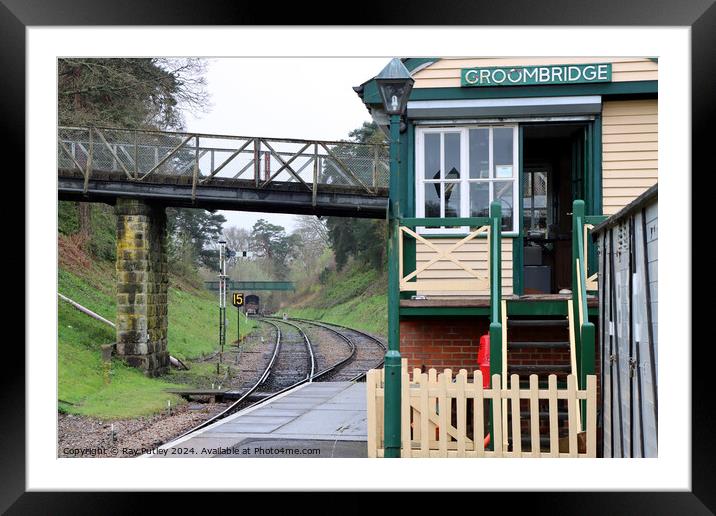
[[57, 127, 389, 376]]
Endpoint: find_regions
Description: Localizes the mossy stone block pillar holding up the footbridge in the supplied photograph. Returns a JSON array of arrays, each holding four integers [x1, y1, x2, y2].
[[115, 198, 169, 376]]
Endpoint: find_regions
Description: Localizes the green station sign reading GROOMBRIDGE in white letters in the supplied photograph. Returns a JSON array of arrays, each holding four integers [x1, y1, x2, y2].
[[460, 63, 612, 87]]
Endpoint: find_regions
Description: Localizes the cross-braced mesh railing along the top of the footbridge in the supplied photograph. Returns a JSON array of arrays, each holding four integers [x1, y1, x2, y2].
[[57, 127, 389, 200]]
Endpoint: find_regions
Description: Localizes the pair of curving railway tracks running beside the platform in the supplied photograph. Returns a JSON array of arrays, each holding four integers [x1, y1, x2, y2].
[[164, 317, 385, 442]]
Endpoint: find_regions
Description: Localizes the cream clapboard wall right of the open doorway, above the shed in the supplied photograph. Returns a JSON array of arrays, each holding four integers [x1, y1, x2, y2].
[[602, 99, 658, 215]]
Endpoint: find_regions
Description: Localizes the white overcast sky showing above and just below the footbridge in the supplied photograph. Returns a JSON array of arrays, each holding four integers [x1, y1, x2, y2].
[[186, 57, 390, 232]]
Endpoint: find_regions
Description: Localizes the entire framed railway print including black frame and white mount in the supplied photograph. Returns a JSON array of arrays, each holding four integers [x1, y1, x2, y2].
[[0, 0, 716, 514]]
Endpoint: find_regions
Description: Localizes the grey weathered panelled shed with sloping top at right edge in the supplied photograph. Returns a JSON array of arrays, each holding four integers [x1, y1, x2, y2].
[[592, 185, 658, 457]]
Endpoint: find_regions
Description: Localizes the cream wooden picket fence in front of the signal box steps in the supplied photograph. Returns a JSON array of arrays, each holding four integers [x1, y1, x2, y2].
[[366, 361, 597, 458]]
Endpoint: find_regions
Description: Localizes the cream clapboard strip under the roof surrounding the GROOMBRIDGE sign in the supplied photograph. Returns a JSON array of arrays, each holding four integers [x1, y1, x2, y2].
[[413, 57, 658, 88]]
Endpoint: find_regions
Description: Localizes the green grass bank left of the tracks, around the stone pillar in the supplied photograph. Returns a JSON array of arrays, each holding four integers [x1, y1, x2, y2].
[[57, 262, 256, 419]]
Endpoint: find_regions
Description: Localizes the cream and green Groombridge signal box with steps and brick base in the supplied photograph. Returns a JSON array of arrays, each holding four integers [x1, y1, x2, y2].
[[354, 57, 658, 458]]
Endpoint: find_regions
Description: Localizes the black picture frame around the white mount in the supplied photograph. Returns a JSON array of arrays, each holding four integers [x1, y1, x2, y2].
[[0, 0, 716, 515]]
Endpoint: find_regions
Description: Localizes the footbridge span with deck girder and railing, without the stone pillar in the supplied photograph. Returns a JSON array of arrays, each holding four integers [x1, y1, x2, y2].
[[57, 127, 389, 218]]
